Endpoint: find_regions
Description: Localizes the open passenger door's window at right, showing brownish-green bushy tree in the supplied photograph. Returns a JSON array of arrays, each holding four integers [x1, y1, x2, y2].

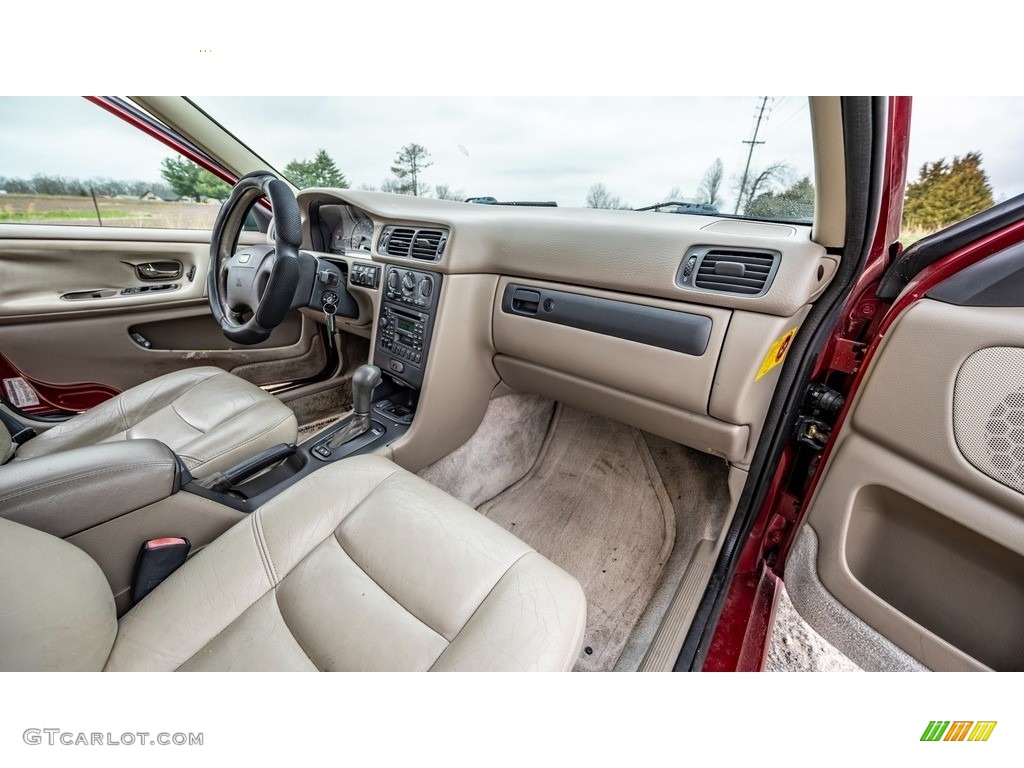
[[900, 96, 1024, 246]]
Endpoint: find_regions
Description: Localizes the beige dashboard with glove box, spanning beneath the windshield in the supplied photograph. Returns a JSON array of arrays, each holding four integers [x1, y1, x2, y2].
[[298, 189, 839, 470]]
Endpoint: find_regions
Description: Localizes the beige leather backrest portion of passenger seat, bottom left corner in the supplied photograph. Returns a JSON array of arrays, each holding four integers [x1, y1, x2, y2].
[[0, 518, 118, 672]]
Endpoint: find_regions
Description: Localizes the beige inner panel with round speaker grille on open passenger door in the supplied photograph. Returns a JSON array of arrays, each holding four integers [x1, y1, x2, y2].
[[807, 299, 1024, 670]]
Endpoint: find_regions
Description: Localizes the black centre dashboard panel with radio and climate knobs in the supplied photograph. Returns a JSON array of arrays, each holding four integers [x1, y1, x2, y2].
[[374, 266, 441, 389]]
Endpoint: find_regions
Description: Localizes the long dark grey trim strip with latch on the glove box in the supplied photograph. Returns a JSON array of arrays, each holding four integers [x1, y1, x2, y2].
[[502, 283, 714, 357]]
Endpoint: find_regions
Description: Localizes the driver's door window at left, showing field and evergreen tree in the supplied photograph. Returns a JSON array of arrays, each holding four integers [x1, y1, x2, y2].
[[0, 96, 230, 229]]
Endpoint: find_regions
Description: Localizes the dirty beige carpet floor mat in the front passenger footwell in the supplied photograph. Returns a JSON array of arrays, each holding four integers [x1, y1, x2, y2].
[[479, 406, 676, 671]]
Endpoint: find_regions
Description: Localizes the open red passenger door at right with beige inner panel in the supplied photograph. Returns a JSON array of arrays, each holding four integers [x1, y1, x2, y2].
[[785, 198, 1024, 671]]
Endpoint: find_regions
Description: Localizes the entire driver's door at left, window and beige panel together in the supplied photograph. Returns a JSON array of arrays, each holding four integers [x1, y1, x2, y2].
[[0, 98, 328, 415]]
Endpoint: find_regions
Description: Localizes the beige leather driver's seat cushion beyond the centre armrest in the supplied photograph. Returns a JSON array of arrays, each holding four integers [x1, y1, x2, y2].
[[9, 367, 298, 477]]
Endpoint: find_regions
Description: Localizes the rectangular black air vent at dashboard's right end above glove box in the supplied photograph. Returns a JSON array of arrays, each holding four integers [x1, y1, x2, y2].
[[676, 247, 781, 296]]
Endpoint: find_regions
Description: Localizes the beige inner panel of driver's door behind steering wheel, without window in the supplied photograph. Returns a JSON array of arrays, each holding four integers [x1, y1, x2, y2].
[[0, 225, 327, 409]]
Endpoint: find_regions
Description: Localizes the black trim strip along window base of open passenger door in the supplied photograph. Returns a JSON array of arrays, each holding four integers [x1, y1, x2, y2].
[[876, 195, 1024, 301]]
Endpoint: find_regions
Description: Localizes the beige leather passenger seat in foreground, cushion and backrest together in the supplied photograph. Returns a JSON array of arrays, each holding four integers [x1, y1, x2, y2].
[[0, 456, 586, 671]]
